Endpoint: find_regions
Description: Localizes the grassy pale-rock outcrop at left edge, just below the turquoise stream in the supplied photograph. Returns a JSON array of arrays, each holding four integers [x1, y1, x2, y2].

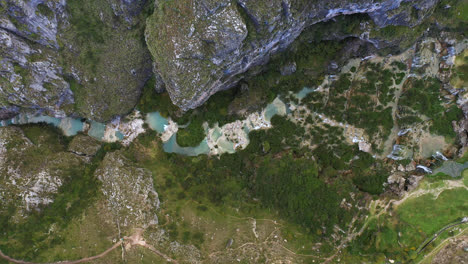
[[0, 127, 84, 222]]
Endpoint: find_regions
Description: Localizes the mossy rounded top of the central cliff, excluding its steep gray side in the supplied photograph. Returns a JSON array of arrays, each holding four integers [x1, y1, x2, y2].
[[146, 1, 247, 109]]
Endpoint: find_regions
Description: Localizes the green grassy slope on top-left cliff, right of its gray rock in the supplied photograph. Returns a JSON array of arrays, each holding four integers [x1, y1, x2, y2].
[[59, 0, 151, 121]]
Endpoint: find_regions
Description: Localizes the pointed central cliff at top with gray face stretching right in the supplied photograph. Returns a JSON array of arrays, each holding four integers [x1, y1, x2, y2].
[[146, 0, 437, 110]]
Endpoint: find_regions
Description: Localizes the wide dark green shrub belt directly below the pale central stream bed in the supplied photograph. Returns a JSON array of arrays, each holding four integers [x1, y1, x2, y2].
[[129, 124, 352, 239]]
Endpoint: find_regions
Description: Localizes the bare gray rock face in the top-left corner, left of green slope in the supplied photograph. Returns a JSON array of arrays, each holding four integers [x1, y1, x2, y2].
[[0, 1, 73, 118]]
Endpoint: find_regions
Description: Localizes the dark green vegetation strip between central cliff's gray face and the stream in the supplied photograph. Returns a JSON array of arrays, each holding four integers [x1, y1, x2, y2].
[[228, 37, 344, 112]]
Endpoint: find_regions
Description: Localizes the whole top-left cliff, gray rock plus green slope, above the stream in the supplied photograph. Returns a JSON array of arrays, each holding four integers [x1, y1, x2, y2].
[[0, 0, 151, 121]]
